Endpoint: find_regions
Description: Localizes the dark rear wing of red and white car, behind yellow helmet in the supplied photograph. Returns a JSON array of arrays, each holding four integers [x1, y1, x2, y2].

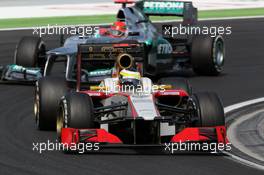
[[77, 41, 146, 90]]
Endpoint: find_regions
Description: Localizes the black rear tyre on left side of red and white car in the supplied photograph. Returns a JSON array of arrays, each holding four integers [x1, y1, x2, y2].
[[34, 77, 68, 130]]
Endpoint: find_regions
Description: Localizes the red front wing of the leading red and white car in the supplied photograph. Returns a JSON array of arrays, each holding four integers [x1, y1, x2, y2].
[[61, 126, 229, 151]]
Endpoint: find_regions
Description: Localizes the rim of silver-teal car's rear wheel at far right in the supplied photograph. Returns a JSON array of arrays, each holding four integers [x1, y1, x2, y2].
[[213, 37, 224, 72]]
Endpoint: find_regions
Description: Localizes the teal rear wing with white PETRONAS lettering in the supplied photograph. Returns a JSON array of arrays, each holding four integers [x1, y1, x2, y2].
[[136, 0, 197, 24]]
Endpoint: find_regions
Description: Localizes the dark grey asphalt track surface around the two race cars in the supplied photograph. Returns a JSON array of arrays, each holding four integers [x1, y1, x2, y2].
[[0, 19, 264, 175]]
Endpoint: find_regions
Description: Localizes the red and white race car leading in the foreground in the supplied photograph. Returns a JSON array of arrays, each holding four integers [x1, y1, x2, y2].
[[53, 45, 228, 152]]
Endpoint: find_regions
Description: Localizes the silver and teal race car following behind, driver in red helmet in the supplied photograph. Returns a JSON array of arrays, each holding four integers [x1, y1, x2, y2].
[[11, 0, 225, 85]]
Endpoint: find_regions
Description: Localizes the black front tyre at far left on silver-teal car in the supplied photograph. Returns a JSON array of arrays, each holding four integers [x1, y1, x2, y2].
[[14, 36, 46, 68]]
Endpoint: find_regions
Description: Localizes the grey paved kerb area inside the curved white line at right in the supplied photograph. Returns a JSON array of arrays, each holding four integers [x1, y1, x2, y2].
[[226, 103, 264, 165]]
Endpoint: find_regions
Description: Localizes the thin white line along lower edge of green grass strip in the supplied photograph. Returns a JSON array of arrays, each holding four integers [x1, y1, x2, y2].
[[0, 16, 264, 31]]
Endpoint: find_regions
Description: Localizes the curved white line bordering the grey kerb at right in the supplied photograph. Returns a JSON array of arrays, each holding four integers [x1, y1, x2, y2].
[[223, 97, 264, 171]]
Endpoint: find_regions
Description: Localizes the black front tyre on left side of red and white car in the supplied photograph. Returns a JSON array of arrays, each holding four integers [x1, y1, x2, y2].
[[57, 92, 96, 139]]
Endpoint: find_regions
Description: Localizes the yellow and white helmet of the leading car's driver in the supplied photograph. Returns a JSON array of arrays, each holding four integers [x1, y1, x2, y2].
[[120, 69, 141, 88]]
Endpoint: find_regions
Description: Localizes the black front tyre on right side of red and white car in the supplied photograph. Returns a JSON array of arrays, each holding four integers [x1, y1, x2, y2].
[[193, 92, 225, 127]]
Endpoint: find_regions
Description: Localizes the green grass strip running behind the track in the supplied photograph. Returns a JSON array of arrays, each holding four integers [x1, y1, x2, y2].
[[0, 8, 264, 28]]
